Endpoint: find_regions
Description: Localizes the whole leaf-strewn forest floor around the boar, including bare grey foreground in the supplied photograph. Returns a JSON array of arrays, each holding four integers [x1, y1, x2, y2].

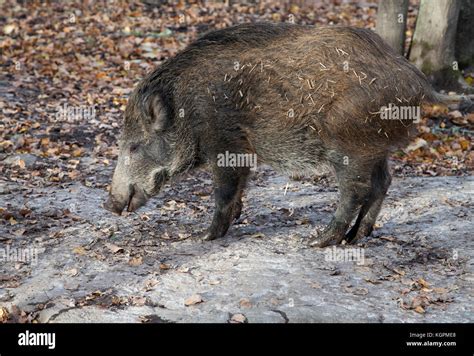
[[0, 0, 474, 322]]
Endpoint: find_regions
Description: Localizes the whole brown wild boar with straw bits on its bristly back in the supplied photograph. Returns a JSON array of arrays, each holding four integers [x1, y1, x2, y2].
[[105, 23, 432, 247]]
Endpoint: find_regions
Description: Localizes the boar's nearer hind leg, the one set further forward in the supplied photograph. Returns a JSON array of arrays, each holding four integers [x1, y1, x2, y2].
[[311, 159, 373, 247]]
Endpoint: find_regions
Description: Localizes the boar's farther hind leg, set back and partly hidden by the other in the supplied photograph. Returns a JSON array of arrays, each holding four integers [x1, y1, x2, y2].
[[345, 158, 392, 243]]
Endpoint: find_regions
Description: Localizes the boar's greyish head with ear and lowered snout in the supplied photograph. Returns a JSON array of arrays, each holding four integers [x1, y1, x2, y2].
[[104, 88, 189, 214]]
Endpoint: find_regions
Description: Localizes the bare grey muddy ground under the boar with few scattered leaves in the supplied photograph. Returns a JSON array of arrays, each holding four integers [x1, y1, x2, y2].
[[0, 169, 474, 323]]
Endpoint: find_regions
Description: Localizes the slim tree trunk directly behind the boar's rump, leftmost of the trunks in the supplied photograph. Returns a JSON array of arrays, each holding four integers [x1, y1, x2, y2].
[[375, 0, 408, 55]]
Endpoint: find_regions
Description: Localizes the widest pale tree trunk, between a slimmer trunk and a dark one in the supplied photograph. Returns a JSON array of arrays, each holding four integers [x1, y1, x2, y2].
[[410, 0, 461, 88]]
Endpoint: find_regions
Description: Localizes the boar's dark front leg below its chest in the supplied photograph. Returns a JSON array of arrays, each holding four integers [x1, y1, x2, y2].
[[203, 167, 250, 240]]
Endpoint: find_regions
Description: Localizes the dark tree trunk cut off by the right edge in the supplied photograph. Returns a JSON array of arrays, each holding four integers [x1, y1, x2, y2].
[[455, 0, 474, 68]]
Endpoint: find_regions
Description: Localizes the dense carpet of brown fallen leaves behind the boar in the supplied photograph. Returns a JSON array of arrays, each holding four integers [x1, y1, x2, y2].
[[0, 1, 474, 191]]
